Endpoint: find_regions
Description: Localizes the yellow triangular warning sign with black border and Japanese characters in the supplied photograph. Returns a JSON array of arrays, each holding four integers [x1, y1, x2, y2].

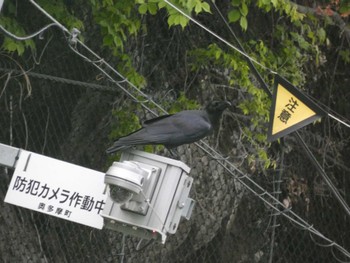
[[267, 75, 327, 142]]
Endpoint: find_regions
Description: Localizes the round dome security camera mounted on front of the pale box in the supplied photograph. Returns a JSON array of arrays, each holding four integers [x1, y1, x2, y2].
[[104, 161, 148, 204]]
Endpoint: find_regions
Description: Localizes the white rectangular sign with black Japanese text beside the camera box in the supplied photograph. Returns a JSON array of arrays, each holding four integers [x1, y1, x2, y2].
[[5, 150, 106, 229]]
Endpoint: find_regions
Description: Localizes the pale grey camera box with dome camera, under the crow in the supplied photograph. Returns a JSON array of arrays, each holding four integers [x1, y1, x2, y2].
[[102, 151, 194, 243]]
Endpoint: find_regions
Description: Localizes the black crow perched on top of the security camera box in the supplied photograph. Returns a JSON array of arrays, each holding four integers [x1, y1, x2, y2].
[[106, 101, 231, 154]]
